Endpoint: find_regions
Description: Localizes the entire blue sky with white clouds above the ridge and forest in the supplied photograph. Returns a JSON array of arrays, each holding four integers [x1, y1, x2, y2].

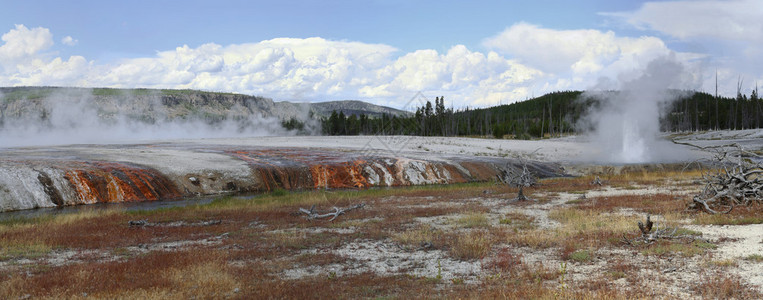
[[0, 0, 763, 109]]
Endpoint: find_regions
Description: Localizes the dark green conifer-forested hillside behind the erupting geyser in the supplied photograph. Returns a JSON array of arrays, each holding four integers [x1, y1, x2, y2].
[[323, 91, 763, 139]]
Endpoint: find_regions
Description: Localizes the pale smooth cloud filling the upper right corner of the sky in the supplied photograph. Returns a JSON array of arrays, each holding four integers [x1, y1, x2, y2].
[[600, 0, 763, 96]]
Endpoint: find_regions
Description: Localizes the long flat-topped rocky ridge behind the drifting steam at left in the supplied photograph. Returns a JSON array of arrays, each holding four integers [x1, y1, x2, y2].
[[0, 86, 411, 126]]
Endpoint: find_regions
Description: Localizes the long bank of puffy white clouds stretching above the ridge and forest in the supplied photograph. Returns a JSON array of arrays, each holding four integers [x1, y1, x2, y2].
[[0, 23, 744, 108]]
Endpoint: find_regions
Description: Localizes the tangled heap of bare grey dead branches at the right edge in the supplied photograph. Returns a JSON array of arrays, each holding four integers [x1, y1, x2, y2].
[[689, 144, 763, 214]]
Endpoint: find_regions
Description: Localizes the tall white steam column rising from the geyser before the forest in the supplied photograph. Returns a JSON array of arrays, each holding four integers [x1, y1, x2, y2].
[[578, 56, 695, 164]]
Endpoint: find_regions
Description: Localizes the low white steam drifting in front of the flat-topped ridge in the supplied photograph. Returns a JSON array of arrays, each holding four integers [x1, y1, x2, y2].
[[0, 89, 310, 148]]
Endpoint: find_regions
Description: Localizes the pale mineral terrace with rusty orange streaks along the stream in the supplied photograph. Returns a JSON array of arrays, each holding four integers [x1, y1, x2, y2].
[[0, 137, 562, 211]]
